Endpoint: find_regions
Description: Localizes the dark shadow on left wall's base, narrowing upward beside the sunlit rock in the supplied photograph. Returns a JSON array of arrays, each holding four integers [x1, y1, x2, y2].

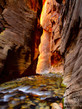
[[0, 0, 43, 83]]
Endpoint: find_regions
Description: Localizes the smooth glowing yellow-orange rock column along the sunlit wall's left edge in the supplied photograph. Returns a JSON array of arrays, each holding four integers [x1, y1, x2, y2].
[[36, 0, 51, 74]]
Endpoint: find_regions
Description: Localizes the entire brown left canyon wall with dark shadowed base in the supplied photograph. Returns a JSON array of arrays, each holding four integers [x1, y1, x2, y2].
[[0, 0, 41, 82]]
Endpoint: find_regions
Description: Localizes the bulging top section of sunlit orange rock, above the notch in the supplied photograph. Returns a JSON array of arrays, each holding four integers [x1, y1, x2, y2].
[[40, 0, 59, 32]]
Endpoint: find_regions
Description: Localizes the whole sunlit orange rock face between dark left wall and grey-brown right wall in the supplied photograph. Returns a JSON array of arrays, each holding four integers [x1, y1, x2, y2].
[[36, 0, 63, 73]]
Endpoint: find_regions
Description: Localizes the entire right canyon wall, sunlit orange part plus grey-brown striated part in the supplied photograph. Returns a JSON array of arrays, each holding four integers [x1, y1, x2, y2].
[[37, 0, 82, 109]]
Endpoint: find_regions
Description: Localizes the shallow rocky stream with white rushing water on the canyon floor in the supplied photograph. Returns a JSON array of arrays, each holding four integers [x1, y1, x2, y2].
[[0, 74, 65, 109]]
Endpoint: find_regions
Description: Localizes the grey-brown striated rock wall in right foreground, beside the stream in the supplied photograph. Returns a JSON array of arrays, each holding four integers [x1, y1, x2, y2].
[[60, 0, 82, 109]]
